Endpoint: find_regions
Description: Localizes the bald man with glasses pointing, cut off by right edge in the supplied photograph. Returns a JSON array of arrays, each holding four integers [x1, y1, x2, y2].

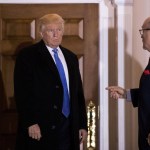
[[106, 17, 150, 150]]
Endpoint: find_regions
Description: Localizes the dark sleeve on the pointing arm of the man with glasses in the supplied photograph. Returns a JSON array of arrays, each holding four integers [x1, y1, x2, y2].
[[130, 88, 140, 107]]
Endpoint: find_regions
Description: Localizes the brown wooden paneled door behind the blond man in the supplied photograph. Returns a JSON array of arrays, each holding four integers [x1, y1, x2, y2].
[[0, 4, 98, 150]]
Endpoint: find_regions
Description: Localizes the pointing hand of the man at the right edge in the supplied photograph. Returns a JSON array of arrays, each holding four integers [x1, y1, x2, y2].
[[106, 86, 127, 100]]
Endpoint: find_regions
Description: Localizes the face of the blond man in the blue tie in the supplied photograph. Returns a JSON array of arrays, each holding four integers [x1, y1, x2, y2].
[[41, 23, 63, 48]]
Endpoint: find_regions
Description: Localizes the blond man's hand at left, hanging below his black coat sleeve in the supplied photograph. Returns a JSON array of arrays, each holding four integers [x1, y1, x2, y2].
[[28, 124, 42, 141]]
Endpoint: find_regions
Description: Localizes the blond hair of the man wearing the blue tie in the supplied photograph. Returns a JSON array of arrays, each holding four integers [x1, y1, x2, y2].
[[38, 14, 64, 32]]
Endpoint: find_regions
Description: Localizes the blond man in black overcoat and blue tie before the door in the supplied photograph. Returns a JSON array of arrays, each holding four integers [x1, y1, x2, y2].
[[14, 14, 87, 150]]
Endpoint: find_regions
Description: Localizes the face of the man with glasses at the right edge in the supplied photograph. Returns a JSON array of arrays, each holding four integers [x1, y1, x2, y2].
[[141, 18, 150, 51]]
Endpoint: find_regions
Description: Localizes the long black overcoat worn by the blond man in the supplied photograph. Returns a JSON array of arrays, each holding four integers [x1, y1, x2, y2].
[[14, 41, 87, 150]]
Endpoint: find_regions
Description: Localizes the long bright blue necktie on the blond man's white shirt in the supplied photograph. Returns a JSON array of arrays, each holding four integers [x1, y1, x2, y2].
[[53, 49, 70, 117]]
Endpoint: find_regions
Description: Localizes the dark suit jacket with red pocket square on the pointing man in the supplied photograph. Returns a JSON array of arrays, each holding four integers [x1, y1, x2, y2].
[[131, 61, 150, 150]]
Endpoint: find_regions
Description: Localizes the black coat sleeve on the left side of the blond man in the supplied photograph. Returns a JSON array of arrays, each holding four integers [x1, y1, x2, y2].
[[14, 51, 37, 128]]
